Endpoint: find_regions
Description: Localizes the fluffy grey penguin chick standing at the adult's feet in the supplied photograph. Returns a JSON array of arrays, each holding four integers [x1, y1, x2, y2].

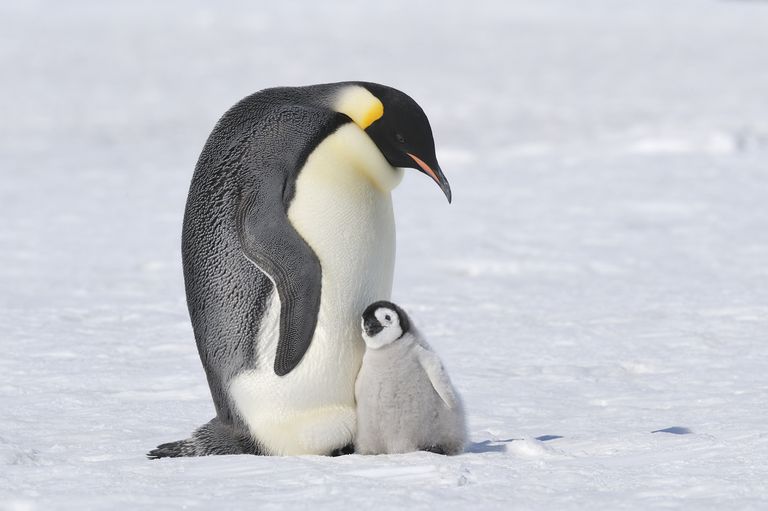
[[355, 301, 467, 455]]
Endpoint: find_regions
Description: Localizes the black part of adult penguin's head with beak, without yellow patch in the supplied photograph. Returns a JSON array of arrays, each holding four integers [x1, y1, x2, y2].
[[360, 82, 451, 202]]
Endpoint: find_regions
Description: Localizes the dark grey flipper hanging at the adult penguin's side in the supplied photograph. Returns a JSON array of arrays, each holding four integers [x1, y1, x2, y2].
[[238, 192, 322, 376]]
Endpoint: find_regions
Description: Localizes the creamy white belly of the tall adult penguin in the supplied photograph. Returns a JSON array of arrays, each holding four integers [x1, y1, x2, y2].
[[229, 127, 401, 455]]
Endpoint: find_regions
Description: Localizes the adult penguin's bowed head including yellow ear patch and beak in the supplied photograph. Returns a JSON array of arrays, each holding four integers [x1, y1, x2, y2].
[[339, 82, 451, 203]]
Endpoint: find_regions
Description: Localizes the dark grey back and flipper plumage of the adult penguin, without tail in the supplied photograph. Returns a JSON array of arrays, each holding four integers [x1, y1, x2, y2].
[[182, 86, 350, 422]]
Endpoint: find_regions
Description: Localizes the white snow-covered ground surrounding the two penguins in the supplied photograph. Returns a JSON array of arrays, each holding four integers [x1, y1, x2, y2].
[[0, 0, 768, 510]]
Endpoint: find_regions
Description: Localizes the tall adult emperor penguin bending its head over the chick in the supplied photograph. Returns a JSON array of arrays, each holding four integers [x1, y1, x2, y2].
[[148, 82, 451, 458]]
